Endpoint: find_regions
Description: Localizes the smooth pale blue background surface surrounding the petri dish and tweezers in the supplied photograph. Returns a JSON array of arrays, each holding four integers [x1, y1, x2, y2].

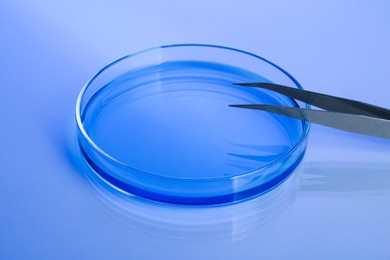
[[0, 0, 390, 259]]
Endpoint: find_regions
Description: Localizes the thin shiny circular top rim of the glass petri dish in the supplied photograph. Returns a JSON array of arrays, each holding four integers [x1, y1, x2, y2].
[[75, 43, 311, 183]]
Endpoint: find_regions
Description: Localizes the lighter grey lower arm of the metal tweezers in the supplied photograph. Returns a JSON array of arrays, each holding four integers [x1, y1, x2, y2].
[[230, 104, 390, 139]]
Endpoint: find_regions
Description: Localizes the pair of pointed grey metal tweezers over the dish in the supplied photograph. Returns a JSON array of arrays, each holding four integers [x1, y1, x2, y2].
[[230, 83, 390, 139]]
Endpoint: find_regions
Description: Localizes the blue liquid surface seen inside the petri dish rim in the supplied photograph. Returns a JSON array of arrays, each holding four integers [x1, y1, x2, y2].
[[82, 61, 302, 179]]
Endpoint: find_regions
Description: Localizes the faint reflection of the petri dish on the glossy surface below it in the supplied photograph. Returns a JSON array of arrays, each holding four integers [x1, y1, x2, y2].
[[80, 150, 306, 246]]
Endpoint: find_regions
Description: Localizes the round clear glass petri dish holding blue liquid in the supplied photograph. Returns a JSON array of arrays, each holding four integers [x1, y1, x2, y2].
[[76, 44, 309, 205]]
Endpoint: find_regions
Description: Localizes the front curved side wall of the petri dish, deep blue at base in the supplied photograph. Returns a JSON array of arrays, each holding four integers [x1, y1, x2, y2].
[[79, 134, 307, 205]]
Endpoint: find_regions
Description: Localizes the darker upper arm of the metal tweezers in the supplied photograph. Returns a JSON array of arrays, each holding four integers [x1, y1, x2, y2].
[[234, 82, 390, 120]]
